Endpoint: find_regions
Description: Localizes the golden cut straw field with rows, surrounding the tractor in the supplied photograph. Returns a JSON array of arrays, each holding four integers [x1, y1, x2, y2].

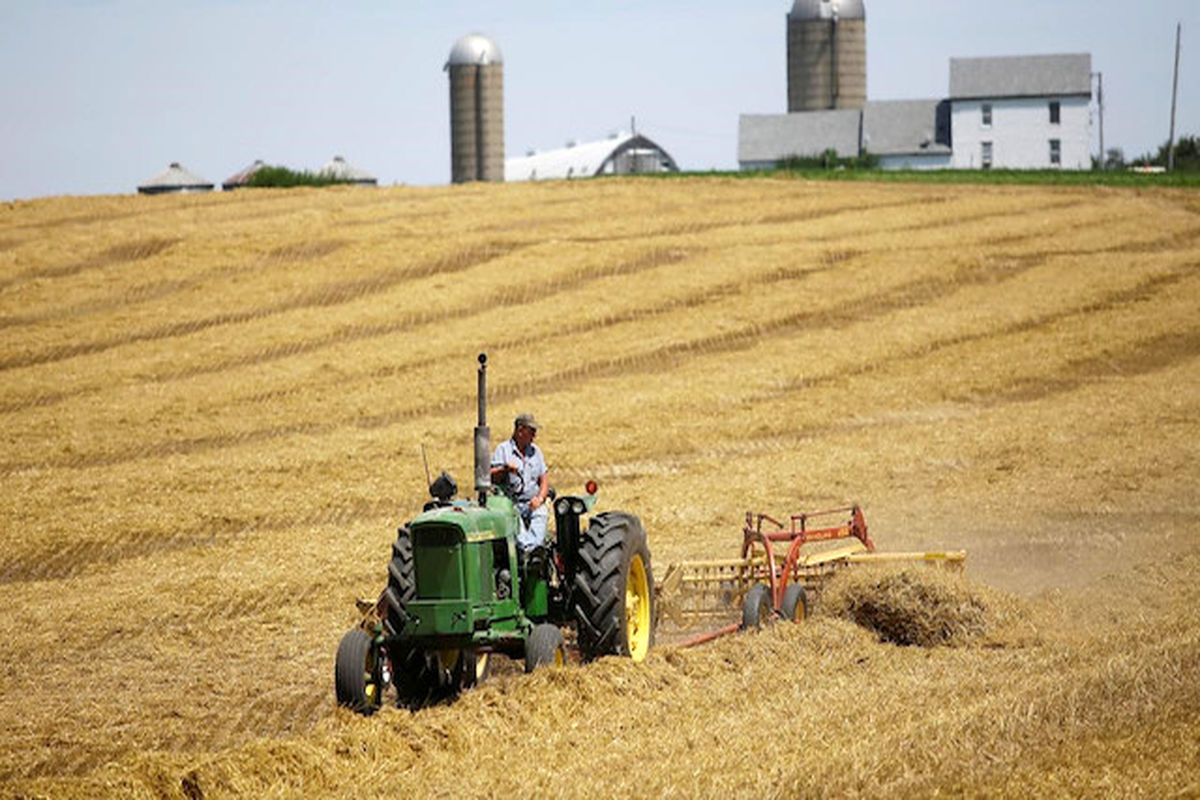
[[0, 178, 1200, 798]]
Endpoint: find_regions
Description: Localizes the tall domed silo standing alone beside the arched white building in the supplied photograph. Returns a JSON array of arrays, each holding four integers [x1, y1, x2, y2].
[[445, 34, 504, 184]]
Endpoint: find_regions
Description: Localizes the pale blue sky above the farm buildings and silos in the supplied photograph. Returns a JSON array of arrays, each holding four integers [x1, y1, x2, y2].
[[0, 0, 1200, 199]]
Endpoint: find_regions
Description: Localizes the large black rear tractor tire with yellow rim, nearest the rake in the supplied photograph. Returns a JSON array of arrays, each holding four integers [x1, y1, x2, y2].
[[571, 511, 655, 662]]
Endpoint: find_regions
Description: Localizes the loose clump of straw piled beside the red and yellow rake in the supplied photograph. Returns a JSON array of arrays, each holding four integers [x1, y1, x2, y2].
[[821, 565, 1024, 648]]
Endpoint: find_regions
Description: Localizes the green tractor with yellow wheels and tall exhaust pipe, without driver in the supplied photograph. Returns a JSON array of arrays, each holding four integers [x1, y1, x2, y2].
[[334, 354, 655, 715]]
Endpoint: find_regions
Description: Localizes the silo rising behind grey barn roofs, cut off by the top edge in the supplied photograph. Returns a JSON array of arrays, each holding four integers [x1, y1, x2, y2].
[[787, 0, 866, 113]]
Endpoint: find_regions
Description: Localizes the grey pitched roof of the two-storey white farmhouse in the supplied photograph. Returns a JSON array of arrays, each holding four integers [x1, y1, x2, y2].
[[950, 53, 1092, 100]]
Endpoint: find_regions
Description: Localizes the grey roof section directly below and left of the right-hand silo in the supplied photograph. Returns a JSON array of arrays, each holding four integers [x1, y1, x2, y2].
[[738, 108, 862, 162]]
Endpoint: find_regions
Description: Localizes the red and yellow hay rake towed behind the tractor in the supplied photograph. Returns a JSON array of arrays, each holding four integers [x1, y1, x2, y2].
[[655, 505, 966, 646]]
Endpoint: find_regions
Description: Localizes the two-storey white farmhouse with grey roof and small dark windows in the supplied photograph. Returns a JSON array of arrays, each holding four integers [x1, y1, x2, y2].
[[949, 53, 1092, 169]]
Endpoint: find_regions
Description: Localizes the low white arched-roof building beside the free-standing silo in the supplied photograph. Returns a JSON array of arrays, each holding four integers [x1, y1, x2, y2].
[[504, 132, 679, 181]]
